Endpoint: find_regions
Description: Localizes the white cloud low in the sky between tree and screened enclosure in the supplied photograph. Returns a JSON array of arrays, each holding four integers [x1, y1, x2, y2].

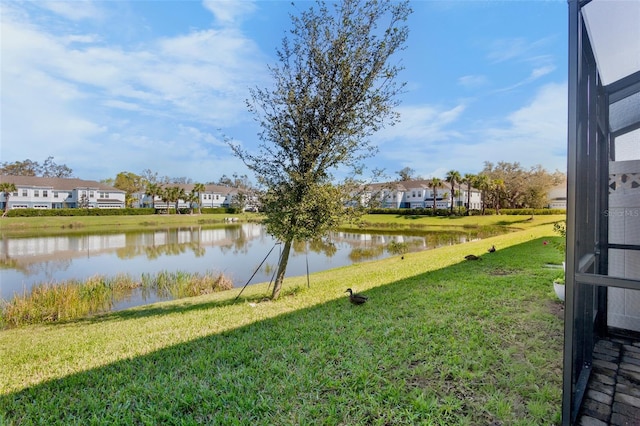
[[374, 83, 567, 178]]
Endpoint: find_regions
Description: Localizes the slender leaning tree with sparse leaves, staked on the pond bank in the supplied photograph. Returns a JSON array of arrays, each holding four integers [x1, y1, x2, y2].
[[230, 0, 411, 299]]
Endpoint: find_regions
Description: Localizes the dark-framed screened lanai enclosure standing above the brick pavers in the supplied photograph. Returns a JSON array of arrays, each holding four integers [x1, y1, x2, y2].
[[562, 0, 640, 424]]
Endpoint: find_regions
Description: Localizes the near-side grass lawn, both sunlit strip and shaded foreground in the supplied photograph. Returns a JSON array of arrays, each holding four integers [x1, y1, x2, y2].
[[0, 216, 563, 425]]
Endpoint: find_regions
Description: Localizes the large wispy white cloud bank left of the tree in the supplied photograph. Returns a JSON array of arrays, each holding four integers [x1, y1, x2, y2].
[[1, 2, 267, 180]]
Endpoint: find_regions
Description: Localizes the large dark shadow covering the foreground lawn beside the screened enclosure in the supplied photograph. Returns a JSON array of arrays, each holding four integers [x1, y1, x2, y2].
[[0, 240, 562, 425]]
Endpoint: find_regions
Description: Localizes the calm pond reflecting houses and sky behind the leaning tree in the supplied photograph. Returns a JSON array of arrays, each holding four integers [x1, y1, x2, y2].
[[0, 224, 505, 310]]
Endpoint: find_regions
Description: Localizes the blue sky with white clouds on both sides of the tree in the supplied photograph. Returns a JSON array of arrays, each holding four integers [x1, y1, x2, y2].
[[0, 0, 567, 182]]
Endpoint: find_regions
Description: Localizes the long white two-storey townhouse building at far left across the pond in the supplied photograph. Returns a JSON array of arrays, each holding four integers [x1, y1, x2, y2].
[[0, 175, 125, 209]]
